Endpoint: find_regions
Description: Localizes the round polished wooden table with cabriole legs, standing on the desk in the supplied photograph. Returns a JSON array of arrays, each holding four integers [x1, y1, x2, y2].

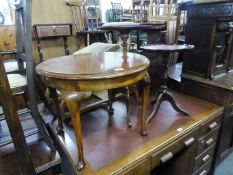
[[36, 52, 150, 170]]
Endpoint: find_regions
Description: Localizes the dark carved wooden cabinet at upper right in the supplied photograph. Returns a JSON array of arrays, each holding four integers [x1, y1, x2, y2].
[[183, 3, 233, 79]]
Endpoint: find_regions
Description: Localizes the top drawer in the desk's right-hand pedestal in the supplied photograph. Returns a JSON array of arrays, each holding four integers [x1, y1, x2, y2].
[[200, 115, 222, 136]]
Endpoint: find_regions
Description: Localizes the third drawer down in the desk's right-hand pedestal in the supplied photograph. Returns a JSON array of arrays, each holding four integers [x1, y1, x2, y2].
[[193, 144, 215, 171]]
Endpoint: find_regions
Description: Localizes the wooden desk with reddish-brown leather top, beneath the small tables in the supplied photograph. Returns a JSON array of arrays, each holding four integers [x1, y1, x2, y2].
[[47, 92, 223, 175]]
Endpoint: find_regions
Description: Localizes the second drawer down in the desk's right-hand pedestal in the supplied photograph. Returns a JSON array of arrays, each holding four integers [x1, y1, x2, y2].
[[197, 126, 219, 155]]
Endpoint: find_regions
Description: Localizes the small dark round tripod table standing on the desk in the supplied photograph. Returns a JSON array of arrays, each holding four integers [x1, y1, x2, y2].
[[141, 44, 194, 123]]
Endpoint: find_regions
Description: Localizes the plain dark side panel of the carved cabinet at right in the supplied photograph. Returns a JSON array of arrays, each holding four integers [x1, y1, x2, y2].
[[183, 18, 216, 78]]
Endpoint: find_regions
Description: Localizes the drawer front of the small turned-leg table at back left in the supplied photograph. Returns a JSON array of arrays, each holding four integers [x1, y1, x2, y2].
[[37, 25, 71, 38]]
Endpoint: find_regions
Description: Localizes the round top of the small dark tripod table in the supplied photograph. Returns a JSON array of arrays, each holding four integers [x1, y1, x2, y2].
[[141, 44, 194, 53]]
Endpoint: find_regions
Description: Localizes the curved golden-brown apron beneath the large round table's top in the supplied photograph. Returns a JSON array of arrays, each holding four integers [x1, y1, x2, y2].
[[41, 69, 148, 91]]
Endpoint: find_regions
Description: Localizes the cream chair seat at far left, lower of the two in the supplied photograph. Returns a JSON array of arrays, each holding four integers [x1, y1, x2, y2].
[[7, 74, 27, 94]]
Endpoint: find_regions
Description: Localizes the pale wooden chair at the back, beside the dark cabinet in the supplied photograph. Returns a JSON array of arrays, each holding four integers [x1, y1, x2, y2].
[[148, 0, 177, 44]]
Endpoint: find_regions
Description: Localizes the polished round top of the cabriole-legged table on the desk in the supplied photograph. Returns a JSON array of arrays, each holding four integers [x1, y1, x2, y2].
[[36, 52, 149, 80]]
